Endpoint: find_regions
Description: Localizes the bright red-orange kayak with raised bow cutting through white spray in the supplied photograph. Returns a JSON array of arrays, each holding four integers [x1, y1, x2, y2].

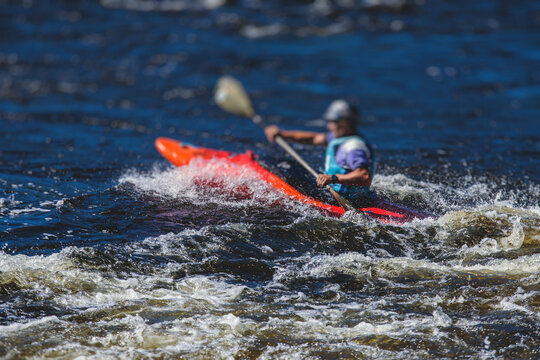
[[155, 137, 430, 224]]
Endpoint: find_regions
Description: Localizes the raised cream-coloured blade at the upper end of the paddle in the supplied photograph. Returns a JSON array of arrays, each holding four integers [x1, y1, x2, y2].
[[214, 76, 255, 117]]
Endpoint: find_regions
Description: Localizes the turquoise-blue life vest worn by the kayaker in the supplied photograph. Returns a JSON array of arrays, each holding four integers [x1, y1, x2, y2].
[[324, 135, 374, 199]]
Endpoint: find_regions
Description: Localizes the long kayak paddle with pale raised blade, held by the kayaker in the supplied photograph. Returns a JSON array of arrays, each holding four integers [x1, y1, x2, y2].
[[214, 76, 357, 212]]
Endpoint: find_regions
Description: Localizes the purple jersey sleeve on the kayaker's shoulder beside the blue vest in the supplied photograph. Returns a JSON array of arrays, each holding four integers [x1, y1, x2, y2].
[[326, 132, 372, 171]]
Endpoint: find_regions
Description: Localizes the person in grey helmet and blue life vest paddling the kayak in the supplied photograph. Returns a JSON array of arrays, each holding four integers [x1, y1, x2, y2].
[[264, 99, 374, 202]]
